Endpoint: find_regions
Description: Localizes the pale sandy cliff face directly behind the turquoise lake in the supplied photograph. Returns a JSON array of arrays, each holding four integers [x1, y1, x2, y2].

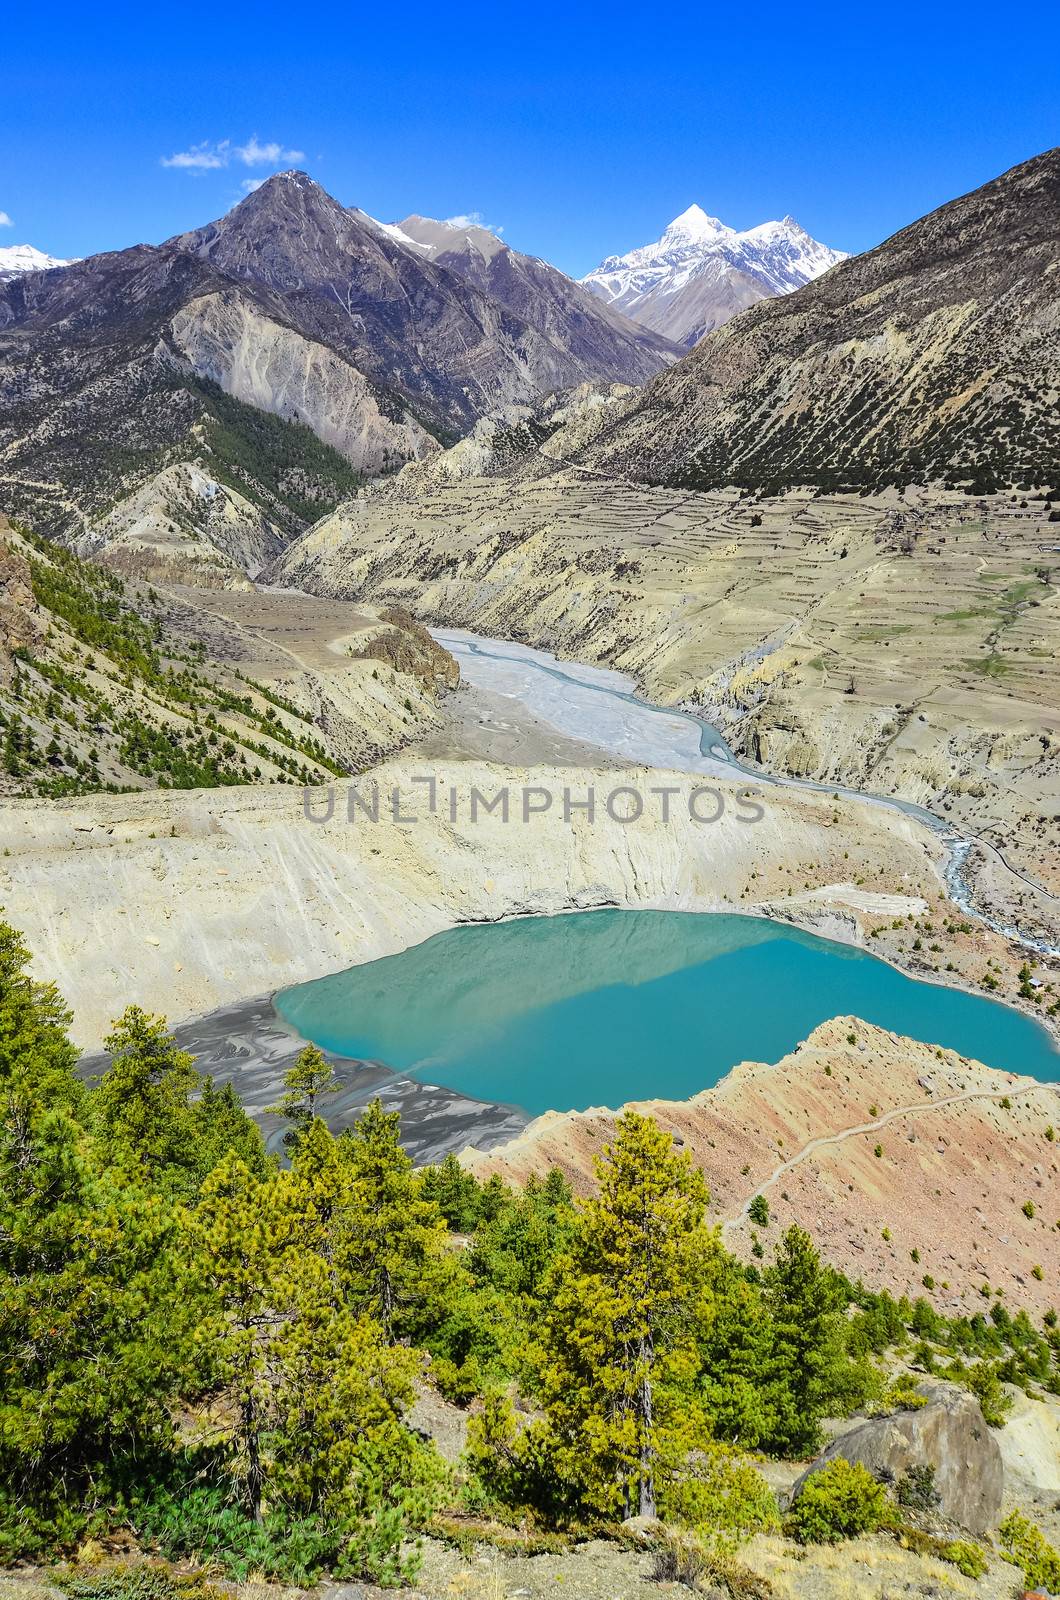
[[0, 764, 938, 1045]]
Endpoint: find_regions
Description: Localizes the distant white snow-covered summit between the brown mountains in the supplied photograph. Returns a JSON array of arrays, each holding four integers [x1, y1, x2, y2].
[[581, 205, 847, 346]]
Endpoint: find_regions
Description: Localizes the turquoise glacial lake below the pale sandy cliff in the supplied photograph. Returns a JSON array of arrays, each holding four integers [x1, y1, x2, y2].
[[275, 910, 1060, 1115]]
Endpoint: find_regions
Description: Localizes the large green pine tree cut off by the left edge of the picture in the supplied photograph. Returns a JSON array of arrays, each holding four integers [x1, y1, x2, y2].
[[0, 925, 197, 1555]]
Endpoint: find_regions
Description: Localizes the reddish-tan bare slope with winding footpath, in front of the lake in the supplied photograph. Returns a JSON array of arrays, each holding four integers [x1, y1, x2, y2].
[[464, 1016, 1060, 1315]]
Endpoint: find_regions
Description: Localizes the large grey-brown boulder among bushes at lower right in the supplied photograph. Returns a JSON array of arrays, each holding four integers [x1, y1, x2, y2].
[[793, 1382, 1004, 1533]]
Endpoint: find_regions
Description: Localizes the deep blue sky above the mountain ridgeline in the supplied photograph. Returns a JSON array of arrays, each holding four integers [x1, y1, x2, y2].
[[0, 0, 1060, 275]]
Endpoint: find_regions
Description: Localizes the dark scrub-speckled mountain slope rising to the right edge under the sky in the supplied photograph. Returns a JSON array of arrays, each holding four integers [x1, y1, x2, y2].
[[581, 150, 1060, 490]]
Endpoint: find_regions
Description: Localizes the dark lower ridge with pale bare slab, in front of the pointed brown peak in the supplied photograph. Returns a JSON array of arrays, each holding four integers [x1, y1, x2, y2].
[[0, 236, 398, 538]]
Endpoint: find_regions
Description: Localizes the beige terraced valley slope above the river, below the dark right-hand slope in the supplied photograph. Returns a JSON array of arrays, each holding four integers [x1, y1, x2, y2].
[[275, 467, 1060, 908]]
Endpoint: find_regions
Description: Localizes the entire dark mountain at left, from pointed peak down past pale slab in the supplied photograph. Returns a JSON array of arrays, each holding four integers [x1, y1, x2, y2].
[[0, 173, 673, 553]]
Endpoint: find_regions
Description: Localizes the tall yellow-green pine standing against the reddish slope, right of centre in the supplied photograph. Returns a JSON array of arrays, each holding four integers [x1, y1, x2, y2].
[[538, 1112, 716, 1517]]
